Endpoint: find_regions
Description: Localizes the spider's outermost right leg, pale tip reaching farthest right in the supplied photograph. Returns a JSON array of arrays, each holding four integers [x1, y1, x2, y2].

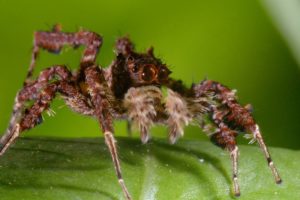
[[193, 80, 282, 183]]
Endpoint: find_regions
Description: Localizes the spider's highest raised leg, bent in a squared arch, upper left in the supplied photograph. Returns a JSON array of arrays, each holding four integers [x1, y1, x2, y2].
[[24, 26, 102, 85]]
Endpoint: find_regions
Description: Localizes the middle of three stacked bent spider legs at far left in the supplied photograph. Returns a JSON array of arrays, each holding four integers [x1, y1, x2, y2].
[[0, 66, 93, 152]]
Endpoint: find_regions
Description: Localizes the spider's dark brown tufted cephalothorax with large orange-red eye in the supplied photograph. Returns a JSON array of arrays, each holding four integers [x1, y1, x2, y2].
[[110, 37, 171, 98]]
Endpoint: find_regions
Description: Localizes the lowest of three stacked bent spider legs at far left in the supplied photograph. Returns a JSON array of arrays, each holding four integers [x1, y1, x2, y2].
[[0, 80, 93, 156]]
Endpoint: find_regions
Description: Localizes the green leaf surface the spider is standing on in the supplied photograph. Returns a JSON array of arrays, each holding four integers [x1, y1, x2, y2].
[[0, 138, 300, 200]]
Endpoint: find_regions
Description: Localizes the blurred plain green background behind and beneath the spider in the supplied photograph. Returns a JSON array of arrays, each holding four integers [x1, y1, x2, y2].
[[0, 0, 300, 149]]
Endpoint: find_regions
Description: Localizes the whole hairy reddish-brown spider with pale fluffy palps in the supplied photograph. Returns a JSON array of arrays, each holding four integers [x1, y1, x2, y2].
[[0, 25, 281, 200]]
